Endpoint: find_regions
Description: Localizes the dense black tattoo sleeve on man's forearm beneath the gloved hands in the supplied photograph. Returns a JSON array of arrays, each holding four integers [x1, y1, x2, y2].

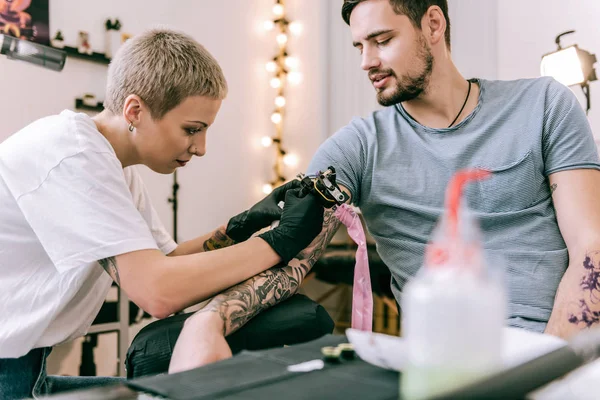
[[198, 210, 340, 335]]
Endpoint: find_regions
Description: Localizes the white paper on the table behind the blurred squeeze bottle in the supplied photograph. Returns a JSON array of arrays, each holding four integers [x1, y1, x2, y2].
[[346, 327, 566, 371]]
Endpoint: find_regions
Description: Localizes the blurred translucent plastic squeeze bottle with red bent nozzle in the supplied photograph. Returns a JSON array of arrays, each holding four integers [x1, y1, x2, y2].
[[400, 169, 506, 399]]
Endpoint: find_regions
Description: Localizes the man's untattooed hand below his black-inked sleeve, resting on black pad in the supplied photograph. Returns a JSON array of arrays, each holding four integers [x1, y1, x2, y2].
[[169, 312, 232, 374]]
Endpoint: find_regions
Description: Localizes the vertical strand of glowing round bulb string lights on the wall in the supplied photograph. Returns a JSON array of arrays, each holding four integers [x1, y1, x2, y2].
[[261, 0, 303, 194]]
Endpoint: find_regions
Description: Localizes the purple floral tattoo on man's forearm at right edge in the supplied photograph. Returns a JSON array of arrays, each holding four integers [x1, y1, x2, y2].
[[569, 251, 600, 328]]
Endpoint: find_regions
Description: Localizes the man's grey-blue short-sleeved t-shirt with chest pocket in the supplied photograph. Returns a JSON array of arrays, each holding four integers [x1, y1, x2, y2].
[[308, 78, 600, 331]]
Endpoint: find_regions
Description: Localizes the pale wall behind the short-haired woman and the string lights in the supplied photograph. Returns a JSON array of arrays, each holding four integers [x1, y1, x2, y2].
[[0, 0, 326, 240]]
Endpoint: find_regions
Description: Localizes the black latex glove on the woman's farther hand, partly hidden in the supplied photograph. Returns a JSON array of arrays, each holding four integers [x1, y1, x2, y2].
[[226, 179, 301, 243]]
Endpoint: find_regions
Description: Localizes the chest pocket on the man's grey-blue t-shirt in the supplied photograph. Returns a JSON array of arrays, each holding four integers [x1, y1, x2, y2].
[[469, 151, 539, 213]]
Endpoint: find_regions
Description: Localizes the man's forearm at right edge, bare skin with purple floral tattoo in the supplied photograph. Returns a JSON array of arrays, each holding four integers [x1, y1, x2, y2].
[[546, 247, 600, 339]]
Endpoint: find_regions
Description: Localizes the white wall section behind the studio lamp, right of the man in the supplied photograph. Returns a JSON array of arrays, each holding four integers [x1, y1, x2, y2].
[[498, 0, 600, 137]]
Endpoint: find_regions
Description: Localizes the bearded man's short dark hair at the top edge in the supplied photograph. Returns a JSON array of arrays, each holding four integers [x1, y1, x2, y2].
[[342, 0, 450, 48]]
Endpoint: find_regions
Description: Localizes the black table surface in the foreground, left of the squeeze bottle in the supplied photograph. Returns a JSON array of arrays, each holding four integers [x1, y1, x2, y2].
[[44, 335, 399, 400]]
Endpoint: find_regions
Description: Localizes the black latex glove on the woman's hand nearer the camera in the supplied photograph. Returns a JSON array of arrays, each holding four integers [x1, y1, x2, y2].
[[259, 189, 323, 265]]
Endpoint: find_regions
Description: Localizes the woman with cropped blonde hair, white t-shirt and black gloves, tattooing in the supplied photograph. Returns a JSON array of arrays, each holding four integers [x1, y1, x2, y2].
[[0, 30, 323, 399]]
